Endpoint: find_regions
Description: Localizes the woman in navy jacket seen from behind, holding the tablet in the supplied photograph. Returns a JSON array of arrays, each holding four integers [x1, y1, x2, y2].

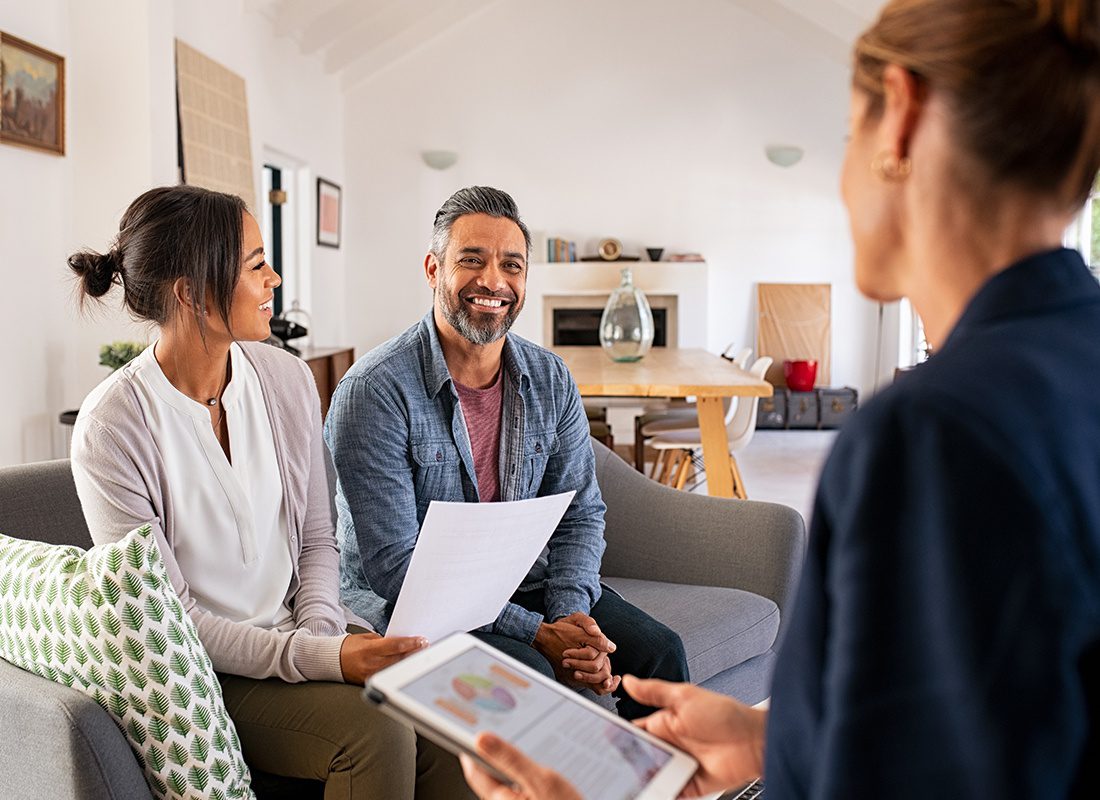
[[464, 0, 1100, 800]]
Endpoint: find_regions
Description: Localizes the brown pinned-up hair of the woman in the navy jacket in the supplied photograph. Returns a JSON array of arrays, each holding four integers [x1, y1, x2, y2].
[[853, 0, 1100, 207]]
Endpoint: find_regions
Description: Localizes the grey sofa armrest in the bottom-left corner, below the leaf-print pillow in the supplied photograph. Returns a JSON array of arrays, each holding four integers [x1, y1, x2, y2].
[[0, 660, 151, 800]]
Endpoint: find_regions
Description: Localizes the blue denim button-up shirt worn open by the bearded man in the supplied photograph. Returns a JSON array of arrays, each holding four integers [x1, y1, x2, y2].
[[325, 311, 605, 643]]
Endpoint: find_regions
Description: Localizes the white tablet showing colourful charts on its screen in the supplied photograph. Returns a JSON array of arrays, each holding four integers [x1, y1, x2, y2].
[[365, 634, 697, 800]]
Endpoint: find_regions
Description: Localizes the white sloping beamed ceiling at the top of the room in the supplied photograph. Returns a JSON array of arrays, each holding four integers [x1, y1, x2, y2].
[[245, 0, 884, 89]]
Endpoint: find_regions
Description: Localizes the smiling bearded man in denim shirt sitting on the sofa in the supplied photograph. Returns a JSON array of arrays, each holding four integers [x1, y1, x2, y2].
[[325, 186, 688, 719]]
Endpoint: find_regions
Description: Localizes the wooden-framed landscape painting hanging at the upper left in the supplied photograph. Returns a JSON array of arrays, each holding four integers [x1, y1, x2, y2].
[[0, 31, 65, 155]]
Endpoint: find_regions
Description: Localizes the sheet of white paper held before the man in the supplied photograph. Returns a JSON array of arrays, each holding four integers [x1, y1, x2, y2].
[[386, 492, 576, 642]]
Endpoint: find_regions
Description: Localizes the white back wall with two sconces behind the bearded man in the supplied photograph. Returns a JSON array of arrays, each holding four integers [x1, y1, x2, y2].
[[338, 0, 877, 387]]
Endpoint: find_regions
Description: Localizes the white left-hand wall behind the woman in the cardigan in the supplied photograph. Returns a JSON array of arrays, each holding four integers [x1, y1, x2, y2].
[[0, 0, 344, 464]]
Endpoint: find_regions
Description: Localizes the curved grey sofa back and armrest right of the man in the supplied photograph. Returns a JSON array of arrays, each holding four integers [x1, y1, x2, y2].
[[592, 440, 806, 634]]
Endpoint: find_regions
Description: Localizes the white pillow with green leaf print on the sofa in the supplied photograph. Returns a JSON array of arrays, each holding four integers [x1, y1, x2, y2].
[[0, 525, 253, 800]]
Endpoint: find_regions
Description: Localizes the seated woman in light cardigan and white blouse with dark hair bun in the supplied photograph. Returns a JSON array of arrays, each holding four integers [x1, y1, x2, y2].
[[68, 186, 468, 800]]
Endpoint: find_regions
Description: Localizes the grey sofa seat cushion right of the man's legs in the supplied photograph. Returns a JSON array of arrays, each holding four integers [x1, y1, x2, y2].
[[603, 578, 779, 683]]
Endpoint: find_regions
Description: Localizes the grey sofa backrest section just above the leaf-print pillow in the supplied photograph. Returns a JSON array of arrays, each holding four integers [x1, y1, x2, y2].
[[0, 459, 91, 548]]
